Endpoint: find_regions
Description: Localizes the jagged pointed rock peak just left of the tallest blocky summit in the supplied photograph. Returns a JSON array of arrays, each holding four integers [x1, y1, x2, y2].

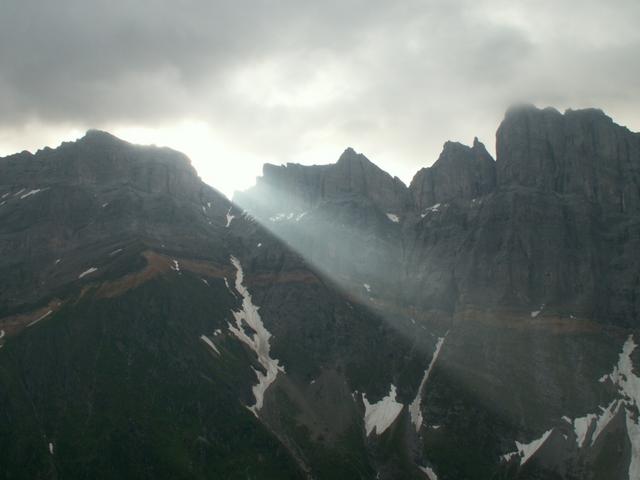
[[409, 138, 496, 211]]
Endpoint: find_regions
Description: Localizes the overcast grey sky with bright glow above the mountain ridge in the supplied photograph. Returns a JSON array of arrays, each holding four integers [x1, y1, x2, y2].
[[0, 0, 640, 195]]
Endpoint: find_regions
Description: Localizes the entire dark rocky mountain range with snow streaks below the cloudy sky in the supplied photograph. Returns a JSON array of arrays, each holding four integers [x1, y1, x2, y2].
[[0, 106, 640, 480]]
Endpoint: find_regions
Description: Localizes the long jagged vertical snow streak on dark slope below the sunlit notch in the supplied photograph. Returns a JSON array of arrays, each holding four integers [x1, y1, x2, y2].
[[229, 256, 284, 417]]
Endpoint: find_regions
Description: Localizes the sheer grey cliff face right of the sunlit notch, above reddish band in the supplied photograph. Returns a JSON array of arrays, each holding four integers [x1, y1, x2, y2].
[[238, 107, 640, 325]]
